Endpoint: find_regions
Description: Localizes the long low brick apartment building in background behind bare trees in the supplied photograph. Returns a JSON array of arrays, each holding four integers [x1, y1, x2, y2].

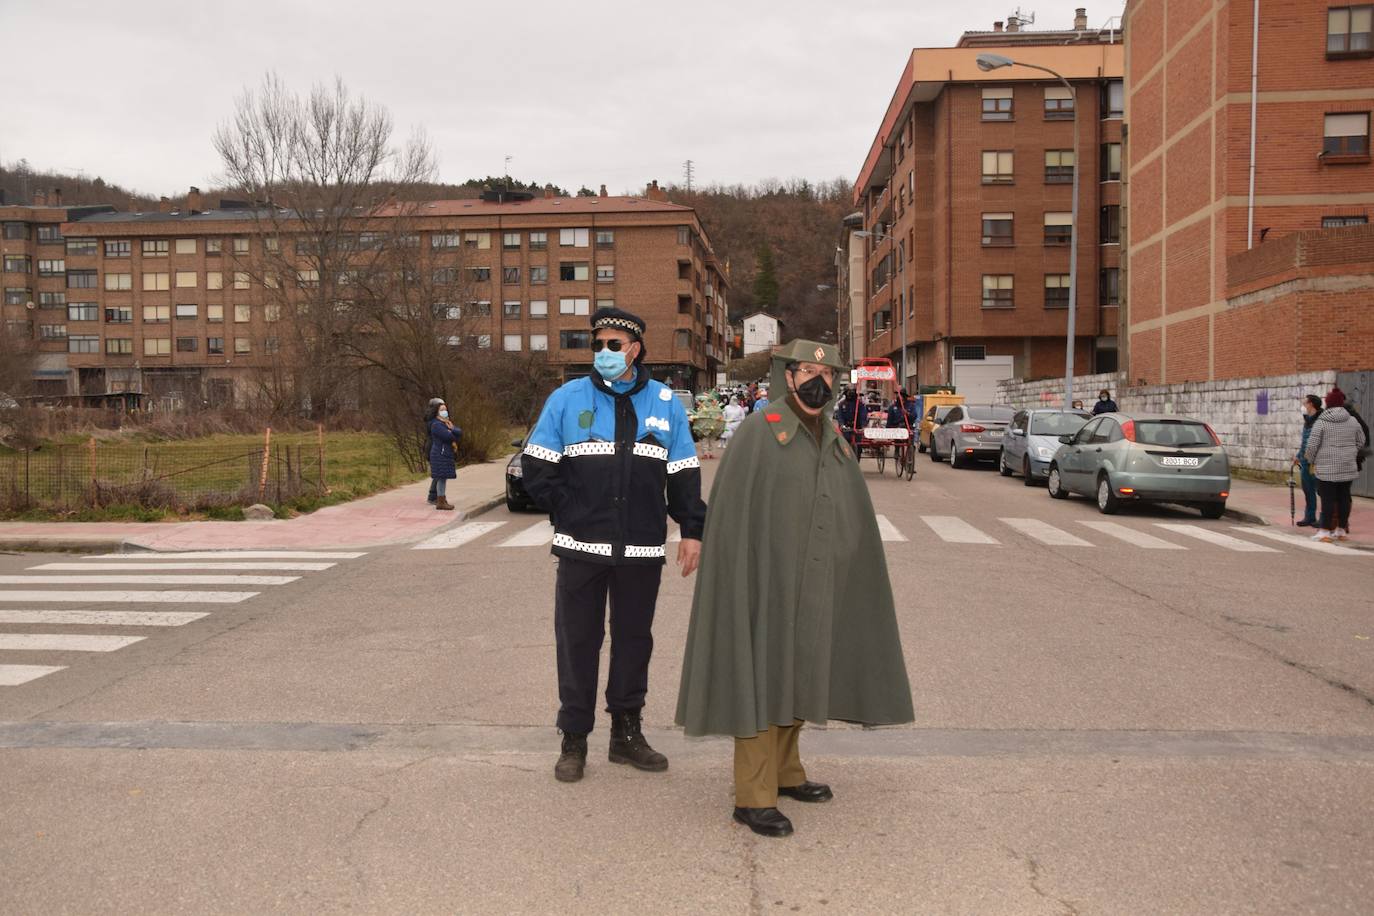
[[0, 183, 728, 407]]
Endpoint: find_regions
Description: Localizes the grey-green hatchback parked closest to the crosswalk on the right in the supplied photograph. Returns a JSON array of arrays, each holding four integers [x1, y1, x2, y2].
[[1048, 413, 1231, 518]]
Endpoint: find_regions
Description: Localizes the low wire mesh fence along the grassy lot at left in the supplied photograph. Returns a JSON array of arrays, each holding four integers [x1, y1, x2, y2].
[[0, 435, 326, 512]]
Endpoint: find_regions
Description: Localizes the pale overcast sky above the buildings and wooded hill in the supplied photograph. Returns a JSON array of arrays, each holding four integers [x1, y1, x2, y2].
[[0, 0, 1124, 195]]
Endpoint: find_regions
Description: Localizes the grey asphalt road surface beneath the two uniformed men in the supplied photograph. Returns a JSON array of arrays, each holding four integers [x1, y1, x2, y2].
[[0, 459, 1374, 913]]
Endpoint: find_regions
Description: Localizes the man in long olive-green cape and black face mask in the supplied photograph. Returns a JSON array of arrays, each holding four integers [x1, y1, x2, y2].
[[677, 341, 914, 836]]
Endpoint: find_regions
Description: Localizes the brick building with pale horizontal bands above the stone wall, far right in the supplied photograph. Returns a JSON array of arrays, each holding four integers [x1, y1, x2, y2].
[[1123, 0, 1374, 385]]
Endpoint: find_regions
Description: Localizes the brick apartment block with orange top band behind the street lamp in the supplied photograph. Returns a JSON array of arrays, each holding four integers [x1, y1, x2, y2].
[[840, 10, 1124, 398]]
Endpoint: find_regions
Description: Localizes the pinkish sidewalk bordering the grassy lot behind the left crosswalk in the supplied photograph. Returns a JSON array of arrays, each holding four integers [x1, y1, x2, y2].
[[0, 459, 506, 551]]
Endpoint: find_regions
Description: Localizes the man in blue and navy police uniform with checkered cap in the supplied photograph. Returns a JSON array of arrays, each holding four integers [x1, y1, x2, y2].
[[521, 308, 706, 783]]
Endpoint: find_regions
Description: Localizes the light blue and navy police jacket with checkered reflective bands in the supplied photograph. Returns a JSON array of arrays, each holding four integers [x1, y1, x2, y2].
[[521, 365, 706, 566]]
